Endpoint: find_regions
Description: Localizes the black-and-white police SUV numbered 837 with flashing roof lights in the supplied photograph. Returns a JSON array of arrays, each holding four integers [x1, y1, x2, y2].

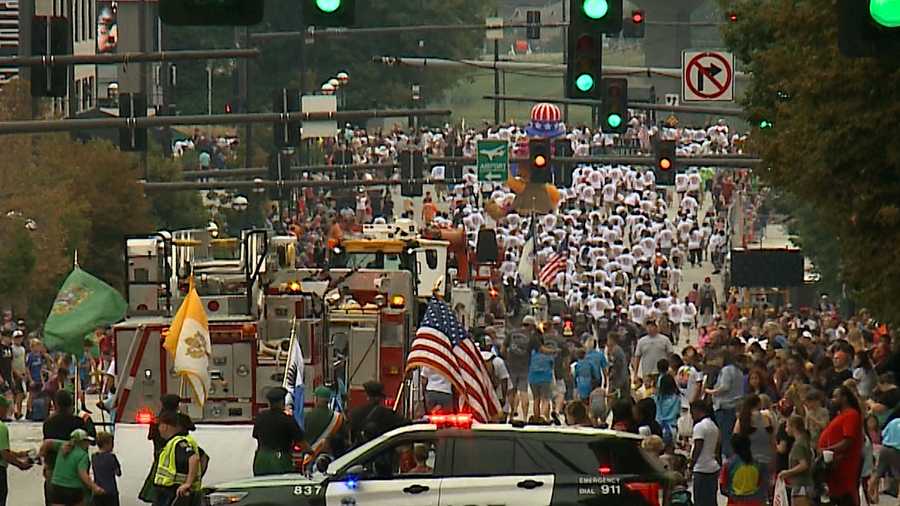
[[206, 415, 668, 506]]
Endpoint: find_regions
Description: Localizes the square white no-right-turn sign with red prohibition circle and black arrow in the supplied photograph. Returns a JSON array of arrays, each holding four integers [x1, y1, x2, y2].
[[681, 51, 734, 102]]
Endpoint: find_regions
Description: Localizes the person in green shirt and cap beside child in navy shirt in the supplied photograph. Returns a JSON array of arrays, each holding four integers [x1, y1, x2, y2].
[[40, 429, 106, 506]]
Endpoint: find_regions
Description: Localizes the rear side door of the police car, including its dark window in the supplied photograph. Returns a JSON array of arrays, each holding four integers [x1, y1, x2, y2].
[[441, 434, 553, 506]]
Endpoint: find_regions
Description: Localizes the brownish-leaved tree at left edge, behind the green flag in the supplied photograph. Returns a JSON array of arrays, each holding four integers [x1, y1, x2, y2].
[[0, 81, 161, 321]]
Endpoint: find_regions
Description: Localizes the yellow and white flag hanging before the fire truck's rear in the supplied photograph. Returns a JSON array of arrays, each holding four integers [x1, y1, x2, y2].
[[163, 277, 212, 407]]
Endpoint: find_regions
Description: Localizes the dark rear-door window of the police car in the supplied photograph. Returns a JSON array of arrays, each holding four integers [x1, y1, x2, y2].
[[453, 437, 515, 477]]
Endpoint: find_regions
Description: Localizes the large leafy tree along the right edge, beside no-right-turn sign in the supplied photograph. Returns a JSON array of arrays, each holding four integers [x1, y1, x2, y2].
[[719, 0, 900, 323]]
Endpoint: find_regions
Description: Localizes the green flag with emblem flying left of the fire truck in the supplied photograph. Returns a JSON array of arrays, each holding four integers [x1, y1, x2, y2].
[[44, 265, 128, 357]]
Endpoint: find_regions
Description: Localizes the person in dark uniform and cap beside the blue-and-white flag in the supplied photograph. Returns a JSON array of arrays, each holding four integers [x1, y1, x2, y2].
[[253, 387, 303, 476]]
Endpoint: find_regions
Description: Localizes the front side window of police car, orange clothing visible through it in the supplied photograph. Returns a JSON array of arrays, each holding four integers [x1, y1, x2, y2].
[[352, 438, 437, 479]]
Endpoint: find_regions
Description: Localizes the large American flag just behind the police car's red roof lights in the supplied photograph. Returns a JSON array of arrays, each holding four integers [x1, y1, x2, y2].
[[406, 297, 501, 422]]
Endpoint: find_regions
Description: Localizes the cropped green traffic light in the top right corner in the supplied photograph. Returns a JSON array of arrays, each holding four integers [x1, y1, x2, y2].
[[838, 0, 900, 59]]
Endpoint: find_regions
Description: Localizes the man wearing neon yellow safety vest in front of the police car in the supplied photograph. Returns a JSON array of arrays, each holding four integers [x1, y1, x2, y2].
[[153, 411, 201, 506]]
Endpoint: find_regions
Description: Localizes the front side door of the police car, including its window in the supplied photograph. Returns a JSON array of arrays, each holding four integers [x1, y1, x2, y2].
[[325, 435, 448, 506]]
